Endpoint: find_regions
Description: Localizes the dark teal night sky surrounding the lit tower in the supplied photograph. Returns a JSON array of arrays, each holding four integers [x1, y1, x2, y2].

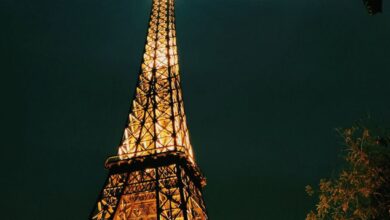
[[0, 0, 390, 220]]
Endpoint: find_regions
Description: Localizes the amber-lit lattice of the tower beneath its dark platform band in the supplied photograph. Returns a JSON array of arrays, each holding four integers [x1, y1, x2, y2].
[[90, 165, 207, 220]]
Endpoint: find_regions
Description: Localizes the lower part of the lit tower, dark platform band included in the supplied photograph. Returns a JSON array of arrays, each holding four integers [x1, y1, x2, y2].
[[89, 152, 208, 220]]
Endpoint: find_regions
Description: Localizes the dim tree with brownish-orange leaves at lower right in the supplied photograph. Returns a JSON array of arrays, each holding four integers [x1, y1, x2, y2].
[[306, 123, 390, 220]]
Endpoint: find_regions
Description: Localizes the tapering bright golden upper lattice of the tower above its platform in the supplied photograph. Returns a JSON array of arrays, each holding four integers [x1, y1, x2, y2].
[[118, 0, 194, 162]]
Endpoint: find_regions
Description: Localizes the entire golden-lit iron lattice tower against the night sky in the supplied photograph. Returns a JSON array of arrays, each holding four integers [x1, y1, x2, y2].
[[90, 0, 208, 220]]
